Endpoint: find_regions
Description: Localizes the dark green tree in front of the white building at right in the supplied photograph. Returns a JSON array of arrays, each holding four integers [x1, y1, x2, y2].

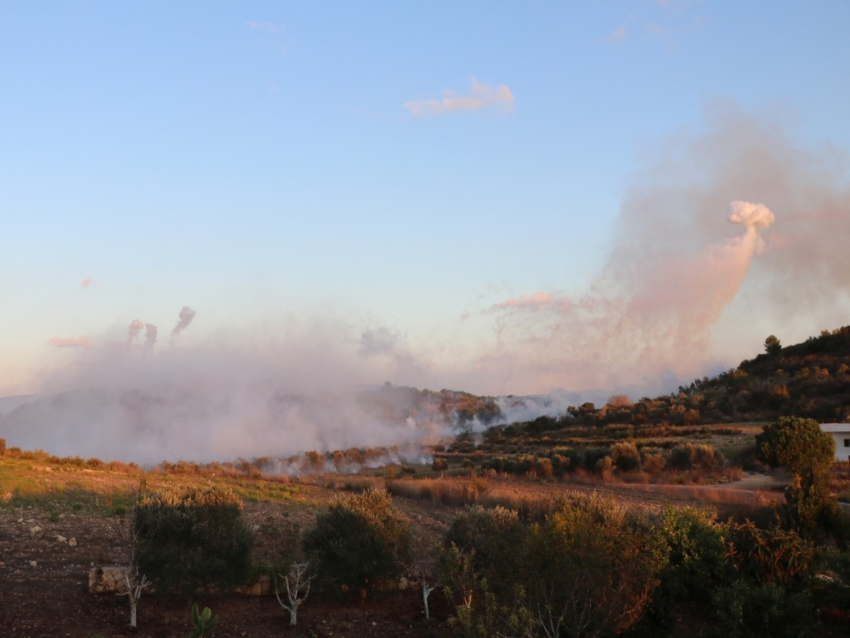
[[756, 417, 835, 530]]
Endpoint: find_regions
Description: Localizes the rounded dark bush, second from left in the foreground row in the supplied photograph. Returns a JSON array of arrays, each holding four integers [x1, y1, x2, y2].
[[304, 488, 411, 597]]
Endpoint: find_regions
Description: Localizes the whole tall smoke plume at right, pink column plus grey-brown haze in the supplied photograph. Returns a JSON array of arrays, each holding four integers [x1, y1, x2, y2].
[[481, 104, 850, 391]]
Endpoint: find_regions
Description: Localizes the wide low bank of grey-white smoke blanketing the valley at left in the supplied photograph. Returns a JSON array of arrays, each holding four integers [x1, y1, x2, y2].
[[0, 316, 450, 464]]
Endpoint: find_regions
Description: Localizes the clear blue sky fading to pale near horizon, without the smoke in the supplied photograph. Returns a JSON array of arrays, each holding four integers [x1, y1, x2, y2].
[[0, 0, 850, 394]]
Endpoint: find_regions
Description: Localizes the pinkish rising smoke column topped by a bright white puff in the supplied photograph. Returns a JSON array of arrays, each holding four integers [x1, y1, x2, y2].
[[491, 201, 775, 389]]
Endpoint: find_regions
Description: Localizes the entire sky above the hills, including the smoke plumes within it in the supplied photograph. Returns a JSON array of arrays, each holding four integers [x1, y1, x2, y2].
[[0, 0, 850, 396]]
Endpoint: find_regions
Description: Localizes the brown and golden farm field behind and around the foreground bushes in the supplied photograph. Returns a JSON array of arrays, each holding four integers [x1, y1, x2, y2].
[[0, 426, 832, 638]]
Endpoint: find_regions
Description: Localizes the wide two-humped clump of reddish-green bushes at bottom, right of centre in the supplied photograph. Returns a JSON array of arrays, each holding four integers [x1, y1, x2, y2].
[[437, 495, 665, 637]]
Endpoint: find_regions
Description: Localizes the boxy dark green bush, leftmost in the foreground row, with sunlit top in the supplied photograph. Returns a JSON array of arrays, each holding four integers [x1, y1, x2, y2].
[[134, 487, 254, 597]]
